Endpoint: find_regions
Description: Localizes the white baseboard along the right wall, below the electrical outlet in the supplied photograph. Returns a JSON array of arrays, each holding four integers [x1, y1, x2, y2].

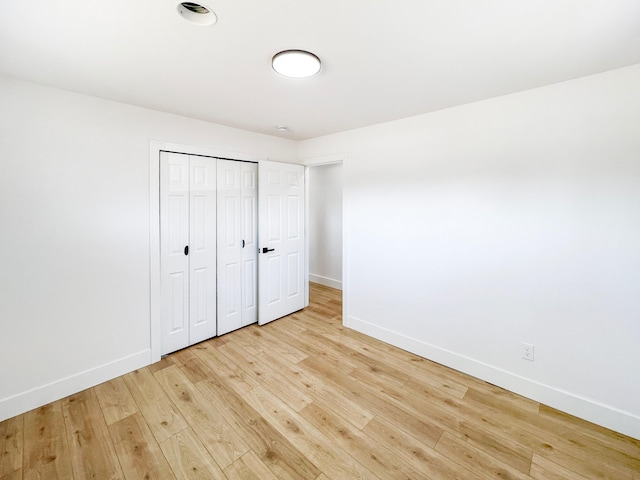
[[344, 316, 640, 439]]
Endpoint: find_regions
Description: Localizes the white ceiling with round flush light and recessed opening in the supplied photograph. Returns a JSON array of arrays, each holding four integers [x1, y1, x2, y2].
[[0, 0, 640, 140]]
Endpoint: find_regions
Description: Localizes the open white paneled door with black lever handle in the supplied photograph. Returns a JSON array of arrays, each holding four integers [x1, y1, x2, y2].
[[258, 161, 305, 325]]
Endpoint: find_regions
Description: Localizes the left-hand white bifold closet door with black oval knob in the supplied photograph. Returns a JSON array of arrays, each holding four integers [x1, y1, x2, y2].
[[160, 152, 216, 355]]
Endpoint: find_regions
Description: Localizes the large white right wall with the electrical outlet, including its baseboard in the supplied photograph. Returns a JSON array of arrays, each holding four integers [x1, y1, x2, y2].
[[300, 65, 640, 438]]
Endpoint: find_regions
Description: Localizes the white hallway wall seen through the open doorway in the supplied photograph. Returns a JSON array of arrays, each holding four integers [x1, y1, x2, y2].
[[307, 163, 342, 290]]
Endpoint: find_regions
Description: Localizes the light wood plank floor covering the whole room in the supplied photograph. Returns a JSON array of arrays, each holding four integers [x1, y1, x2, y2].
[[0, 284, 640, 480]]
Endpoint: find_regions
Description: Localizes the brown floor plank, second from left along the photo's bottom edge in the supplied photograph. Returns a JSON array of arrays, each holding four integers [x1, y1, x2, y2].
[[22, 401, 74, 480]]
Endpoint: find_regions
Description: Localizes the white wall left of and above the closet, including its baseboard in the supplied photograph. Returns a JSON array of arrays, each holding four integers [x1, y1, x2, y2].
[[0, 77, 297, 420]]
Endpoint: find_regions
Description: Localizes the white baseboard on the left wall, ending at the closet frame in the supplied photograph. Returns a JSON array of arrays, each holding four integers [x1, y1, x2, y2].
[[0, 350, 151, 422]]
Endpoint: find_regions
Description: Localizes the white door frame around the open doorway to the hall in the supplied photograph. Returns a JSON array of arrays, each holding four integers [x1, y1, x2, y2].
[[300, 152, 349, 327]]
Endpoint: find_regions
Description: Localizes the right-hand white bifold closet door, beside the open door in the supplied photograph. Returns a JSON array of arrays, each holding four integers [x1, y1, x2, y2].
[[217, 159, 258, 335]]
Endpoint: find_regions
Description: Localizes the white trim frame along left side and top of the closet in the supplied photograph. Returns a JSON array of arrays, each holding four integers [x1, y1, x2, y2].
[[149, 140, 266, 363]]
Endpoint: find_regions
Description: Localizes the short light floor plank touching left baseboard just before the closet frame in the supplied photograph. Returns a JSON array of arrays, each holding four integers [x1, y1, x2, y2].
[[122, 368, 188, 442]]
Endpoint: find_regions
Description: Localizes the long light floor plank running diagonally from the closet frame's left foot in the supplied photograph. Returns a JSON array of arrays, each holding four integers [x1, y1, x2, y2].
[[155, 365, 249, 469]]
